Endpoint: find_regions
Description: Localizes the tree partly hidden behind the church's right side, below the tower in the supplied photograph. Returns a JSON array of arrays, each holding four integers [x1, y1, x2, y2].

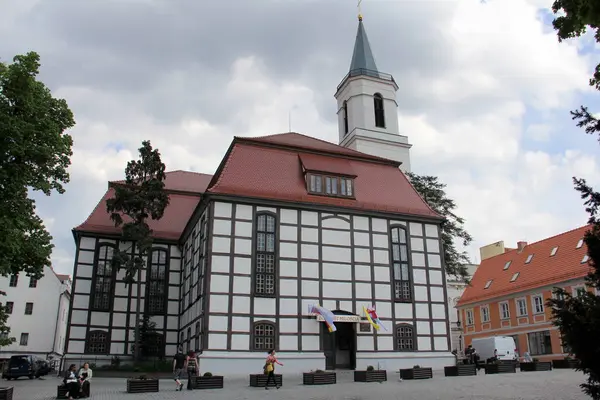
[[407, 172, 473, 282]]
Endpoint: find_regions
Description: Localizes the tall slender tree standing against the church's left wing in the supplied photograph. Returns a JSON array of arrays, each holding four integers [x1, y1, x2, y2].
[[106, 141, 169, 361]]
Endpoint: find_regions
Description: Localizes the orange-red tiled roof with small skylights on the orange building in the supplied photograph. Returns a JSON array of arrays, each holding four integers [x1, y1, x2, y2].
[[458, 226, 590, 306]]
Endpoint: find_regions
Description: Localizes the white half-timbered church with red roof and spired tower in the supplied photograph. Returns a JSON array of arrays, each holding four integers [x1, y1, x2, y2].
[[66, 14, 454, 376]]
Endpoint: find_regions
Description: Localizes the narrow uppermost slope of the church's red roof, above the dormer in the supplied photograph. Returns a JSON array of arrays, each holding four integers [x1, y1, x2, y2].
[[235, 132, 400, 164]]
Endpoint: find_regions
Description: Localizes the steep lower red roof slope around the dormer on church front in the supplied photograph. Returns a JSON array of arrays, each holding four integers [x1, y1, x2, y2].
[[208, 139, 440, 218]]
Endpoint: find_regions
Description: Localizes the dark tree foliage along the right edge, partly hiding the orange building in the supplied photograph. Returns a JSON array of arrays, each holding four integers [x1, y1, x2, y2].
[[547, 0, 600, 400]]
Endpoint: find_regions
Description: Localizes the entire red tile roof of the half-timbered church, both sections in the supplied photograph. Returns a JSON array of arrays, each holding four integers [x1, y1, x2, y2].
[[74, 133, 441, 240]]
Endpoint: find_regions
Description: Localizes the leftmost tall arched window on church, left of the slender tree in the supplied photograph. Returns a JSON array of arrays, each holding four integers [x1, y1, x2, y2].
[[91, 243, 115, 311]]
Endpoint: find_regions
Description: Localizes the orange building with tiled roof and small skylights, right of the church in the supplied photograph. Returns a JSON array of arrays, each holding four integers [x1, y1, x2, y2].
[[456, 226, 593, 360]]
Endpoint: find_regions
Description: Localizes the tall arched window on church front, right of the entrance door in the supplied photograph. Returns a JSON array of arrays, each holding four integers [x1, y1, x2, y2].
[[390, 226, 412, 302]]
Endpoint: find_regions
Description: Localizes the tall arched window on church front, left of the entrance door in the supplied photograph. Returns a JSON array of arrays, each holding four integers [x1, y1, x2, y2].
[[254, 213, 276, 297]]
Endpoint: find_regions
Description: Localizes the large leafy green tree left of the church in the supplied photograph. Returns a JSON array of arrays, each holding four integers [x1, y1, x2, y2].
[[0, 52, 75, 346]]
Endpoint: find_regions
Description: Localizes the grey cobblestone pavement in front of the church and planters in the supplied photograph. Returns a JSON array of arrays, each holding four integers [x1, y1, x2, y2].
[[7, 370, 589, 400]]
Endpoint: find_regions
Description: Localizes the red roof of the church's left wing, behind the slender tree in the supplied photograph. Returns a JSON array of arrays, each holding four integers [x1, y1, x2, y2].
[[74, 185, 200, 240]]
